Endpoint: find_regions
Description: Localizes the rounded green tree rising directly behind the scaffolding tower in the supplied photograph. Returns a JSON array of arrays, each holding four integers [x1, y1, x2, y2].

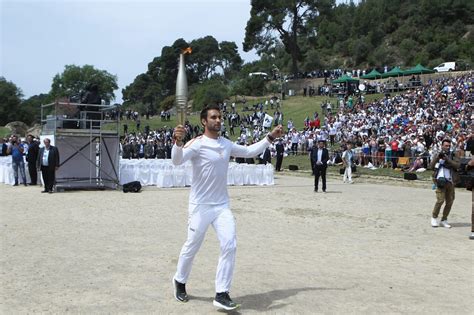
[[49, 65, 118, 103]]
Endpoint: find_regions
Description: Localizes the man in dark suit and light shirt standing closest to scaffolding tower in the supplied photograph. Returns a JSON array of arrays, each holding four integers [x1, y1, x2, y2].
[[36, 138, 59, 194]]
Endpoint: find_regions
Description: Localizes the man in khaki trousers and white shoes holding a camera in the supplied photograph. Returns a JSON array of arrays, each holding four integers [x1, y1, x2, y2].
[[429, 139, 460, 228]]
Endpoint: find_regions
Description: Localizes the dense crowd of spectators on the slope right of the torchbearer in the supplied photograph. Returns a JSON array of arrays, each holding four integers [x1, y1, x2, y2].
[[278, 74, 474, 170]]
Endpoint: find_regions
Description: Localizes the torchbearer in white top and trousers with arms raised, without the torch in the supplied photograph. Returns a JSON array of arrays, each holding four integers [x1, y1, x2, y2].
[[171, 106, 282, 310]]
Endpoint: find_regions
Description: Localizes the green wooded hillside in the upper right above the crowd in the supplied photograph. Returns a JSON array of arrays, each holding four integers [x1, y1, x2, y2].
[[302, 0, 474, 71]]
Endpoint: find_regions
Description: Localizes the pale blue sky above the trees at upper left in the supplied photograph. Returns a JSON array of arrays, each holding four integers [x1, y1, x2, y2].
[[0, 0, 258, 103]]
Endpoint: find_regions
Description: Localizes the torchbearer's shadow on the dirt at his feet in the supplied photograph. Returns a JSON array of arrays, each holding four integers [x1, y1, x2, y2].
[[190, 287, 350, 315]]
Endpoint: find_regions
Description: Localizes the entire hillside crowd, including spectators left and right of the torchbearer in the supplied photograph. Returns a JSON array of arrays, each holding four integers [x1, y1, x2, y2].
[[118, 75, 474, 170]]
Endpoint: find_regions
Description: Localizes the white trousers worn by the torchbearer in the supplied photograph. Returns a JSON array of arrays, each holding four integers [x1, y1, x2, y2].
[[174, 204, 237, 292]]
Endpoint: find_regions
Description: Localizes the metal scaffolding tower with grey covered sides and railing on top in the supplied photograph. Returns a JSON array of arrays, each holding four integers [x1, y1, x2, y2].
[[41, 101, 120, 191]]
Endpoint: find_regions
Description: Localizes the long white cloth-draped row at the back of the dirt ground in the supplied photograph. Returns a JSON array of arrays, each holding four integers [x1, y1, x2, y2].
[[0, 156, 274, 187]]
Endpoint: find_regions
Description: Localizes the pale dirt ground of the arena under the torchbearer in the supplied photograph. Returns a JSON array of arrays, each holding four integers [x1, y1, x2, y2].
[[0, 175, 474, 314]]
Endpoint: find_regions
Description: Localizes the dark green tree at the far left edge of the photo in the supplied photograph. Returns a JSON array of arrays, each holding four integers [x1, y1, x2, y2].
[[0, 77, 24, 126]]
